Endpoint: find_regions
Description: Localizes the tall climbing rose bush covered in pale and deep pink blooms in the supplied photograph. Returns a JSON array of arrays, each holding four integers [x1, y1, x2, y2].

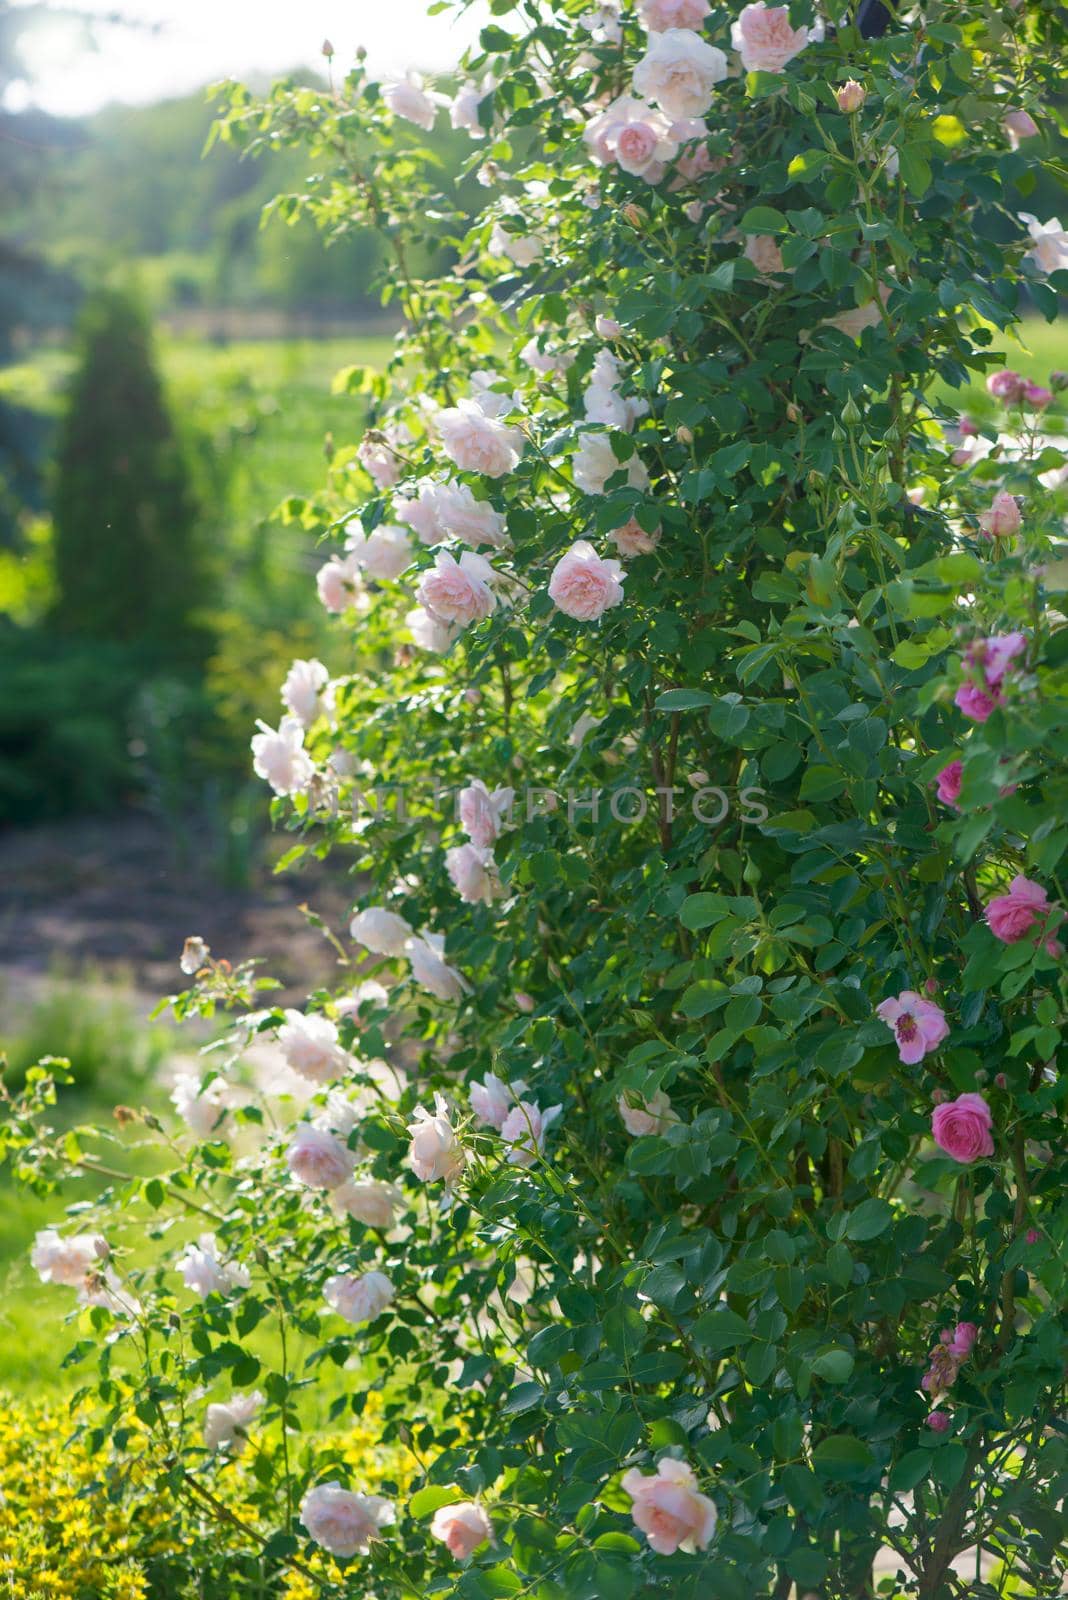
[[8, 0, 1068, 1600]]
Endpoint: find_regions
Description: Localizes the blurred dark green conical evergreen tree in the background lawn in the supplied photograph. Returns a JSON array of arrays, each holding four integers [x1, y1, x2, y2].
[[54, 290, 201, 659]]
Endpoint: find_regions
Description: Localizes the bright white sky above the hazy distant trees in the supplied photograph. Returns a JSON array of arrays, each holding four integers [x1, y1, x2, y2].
[[8, 0, 488, 115]]
